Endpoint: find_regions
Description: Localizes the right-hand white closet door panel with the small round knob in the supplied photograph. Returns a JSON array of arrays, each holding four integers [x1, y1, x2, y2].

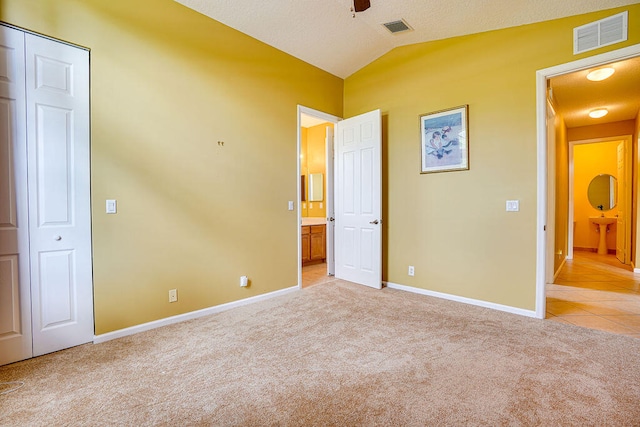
[[26, 34, 94, 356]]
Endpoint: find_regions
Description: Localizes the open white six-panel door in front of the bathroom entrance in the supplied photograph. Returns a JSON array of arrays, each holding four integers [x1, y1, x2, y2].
[[335, 110, 382, 289]]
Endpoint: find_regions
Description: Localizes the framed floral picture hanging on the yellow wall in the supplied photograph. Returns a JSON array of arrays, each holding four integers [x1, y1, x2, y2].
[[420, 105, 469, 173]]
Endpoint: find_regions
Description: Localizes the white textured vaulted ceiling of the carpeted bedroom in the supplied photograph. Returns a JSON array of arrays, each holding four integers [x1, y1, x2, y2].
[[176, 0, 637, 78]]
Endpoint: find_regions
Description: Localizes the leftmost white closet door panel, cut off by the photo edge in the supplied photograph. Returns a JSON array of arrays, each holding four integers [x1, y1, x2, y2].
[[0, 26, 32, 365]]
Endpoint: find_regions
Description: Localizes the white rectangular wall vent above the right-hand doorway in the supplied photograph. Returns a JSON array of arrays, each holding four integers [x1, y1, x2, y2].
[[573, 11, 629, 55]]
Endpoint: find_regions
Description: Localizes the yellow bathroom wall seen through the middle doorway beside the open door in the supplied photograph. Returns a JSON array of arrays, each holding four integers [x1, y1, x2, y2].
[[305, 124, 327, 218]]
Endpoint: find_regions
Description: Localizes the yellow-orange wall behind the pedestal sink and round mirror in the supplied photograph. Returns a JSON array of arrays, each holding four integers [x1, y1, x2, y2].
[[573, 141, 620, 249]]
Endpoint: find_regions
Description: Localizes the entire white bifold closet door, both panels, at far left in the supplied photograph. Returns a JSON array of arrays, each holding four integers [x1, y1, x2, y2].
[[0, 26, 94, 364]]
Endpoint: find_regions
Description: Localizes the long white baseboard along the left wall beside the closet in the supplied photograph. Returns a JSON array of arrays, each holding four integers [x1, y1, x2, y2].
[[93, 286, 300, 344]]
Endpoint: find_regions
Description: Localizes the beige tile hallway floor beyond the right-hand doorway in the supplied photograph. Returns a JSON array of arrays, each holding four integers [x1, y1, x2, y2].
[[546, 251, 640, 338]]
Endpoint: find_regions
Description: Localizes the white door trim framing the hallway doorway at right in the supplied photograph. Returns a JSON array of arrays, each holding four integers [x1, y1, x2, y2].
[[536, 44, 640, 319]]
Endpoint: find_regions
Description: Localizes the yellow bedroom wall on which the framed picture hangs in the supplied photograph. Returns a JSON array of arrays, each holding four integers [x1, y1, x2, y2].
[[344, 5, 640, 310]]
